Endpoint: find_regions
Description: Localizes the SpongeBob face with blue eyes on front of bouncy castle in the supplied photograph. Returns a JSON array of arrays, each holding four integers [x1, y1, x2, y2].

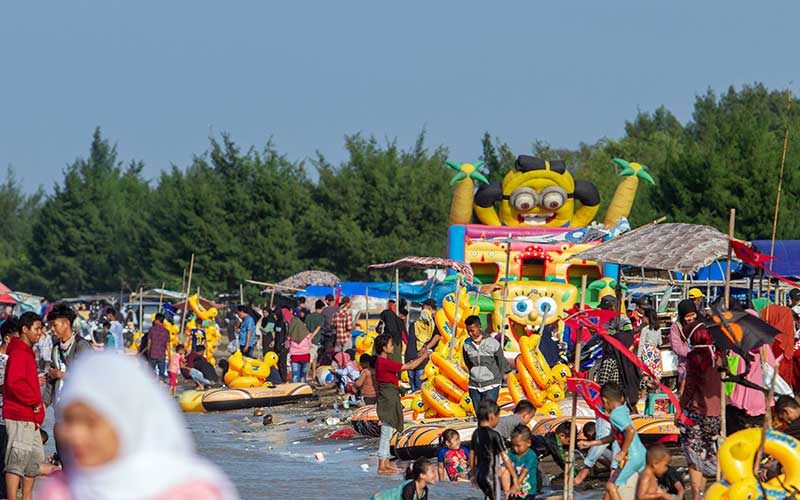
[[492, 281, 578, 351]]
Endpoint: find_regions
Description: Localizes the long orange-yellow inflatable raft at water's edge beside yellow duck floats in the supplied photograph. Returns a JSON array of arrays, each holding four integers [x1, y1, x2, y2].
[[178, 383, 317, 413]]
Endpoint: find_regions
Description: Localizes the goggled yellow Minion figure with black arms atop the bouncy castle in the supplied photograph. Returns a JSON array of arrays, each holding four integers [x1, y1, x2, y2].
[[474, 155, 600, 227]]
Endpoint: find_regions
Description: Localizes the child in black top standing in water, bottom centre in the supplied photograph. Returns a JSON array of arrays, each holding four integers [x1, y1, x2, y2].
[[469, 399, 519, 500]]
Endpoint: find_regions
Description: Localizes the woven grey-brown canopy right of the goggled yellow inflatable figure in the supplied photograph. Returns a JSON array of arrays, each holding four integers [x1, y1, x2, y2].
[[572, 223, 728, 273]]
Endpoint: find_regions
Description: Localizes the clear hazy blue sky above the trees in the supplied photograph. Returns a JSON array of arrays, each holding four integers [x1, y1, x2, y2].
[[0, 0, 800, 192]]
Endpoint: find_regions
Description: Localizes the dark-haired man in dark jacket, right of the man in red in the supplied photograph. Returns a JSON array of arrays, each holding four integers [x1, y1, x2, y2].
[[42, 303, 92, 406]]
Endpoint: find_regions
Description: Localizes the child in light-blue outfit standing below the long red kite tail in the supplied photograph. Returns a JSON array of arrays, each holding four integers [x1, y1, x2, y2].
[[595, 382, 647, 500]]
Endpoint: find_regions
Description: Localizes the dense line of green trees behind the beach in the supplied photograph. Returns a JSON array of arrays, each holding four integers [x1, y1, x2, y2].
[[0, 84, 800, 298]]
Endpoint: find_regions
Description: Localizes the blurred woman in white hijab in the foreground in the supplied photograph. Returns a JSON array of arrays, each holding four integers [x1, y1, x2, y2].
[[37, 352, 239, 500]]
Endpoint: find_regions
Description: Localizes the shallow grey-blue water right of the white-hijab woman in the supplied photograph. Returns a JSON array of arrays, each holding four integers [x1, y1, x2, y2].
[[186, 406, 601, 500]]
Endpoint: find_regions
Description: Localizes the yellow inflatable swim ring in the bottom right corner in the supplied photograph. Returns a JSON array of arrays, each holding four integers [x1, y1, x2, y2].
[[706, 429, 800, 500]]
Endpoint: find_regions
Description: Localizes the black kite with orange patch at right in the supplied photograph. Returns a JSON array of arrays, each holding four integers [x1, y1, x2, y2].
[[704, 301, 780, 359]]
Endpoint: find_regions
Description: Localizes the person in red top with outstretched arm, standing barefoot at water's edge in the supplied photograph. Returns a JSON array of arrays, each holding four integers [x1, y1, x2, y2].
[[374, 335, 431, 474]]
